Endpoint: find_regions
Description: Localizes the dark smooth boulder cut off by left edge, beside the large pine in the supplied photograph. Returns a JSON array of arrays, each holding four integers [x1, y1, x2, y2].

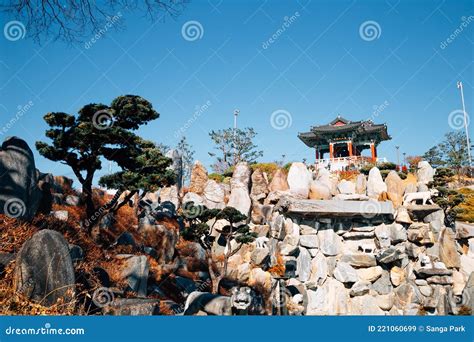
[[0, 137, 41, 220]]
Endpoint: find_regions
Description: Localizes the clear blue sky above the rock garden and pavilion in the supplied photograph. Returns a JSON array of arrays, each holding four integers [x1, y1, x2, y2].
[[0, 0, 474, 184]]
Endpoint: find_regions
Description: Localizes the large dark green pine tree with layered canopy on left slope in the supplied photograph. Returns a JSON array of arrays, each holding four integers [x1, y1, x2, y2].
[[36, 95, 171, 230]]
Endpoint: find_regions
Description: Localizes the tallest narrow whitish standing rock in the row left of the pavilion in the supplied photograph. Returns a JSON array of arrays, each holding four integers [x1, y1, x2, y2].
[[227, 162, 252, 216]]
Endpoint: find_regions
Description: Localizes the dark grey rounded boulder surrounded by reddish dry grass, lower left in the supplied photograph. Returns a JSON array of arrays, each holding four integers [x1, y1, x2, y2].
[[14, 229, 75, 306]]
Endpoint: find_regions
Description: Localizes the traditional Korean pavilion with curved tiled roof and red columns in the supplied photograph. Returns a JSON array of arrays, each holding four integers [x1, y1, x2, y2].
[[298, 116, 391, 170]]
